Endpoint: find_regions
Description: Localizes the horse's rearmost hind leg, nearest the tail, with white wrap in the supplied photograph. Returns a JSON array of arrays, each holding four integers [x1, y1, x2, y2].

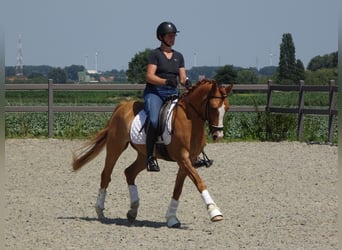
[[95, 139, 128, 219]]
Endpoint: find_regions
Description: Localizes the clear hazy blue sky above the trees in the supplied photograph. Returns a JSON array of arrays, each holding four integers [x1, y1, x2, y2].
[[0, 0, 342, 71]]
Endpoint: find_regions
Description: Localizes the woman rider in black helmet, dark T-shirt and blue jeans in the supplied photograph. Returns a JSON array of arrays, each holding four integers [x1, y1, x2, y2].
[[144, 22, 191, 171]]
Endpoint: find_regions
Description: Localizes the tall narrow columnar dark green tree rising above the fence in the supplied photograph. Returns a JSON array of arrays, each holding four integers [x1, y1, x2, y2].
[[277, 33, 297, 84]]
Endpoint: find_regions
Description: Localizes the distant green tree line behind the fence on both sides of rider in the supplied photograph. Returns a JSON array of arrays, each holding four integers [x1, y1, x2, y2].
[[5, 33, 338, 84]]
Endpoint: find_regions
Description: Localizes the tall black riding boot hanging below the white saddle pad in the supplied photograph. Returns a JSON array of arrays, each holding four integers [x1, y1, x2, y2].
[[146, 124, 160, 172]]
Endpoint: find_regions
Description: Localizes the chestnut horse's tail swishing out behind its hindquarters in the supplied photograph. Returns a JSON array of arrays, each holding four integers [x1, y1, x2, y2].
[[72, 126, 109, 171]]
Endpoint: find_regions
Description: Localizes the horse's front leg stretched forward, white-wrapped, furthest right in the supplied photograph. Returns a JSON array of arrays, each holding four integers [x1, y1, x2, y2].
[[178, 156, 223, 222]]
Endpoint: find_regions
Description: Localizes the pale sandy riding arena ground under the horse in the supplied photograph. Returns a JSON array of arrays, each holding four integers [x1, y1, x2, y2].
[[5, 139, 338, 250]]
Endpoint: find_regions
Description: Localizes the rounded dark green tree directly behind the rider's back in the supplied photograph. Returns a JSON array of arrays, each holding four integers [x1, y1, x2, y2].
[[127, 49, 151, 84]]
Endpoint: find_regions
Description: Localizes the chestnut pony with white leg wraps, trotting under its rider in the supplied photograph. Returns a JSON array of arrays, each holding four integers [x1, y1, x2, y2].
[[72, 79, 233, 227]]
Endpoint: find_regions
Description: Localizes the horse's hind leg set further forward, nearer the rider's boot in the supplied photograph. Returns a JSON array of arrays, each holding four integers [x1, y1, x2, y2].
[[125, 153, 146, 223]]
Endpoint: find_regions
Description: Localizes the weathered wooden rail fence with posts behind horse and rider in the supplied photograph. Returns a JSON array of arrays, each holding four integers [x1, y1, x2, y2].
[[5, 80, 338, 142]]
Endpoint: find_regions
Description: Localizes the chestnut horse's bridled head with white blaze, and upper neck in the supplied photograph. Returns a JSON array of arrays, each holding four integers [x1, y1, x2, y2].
[[184, 79, 233, 141]]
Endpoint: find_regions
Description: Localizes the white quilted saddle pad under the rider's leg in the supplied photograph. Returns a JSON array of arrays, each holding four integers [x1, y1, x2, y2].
[[130, 100, 178, 145]]
